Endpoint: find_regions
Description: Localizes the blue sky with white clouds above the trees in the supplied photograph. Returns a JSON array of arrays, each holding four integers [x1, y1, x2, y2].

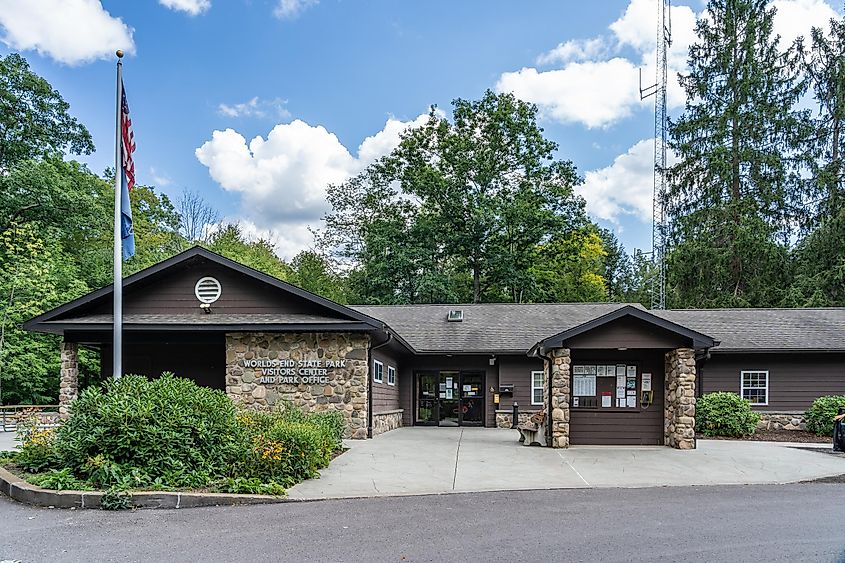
[[0, 0, 841, 257]]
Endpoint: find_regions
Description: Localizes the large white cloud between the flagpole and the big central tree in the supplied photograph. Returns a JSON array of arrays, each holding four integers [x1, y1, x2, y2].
[[196, 114, 427, 257]]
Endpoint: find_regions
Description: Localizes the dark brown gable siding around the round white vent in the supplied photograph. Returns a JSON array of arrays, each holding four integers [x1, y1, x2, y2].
[[73, 259, 342, 318]]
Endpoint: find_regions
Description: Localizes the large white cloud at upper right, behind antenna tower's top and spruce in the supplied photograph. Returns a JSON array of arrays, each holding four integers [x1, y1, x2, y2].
[[496, 0, 837, 128]]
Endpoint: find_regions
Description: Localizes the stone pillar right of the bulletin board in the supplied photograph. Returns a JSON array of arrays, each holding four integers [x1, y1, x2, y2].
[[663, 348, 695, 450]]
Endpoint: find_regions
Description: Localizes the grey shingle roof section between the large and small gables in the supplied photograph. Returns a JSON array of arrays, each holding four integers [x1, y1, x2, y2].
[[351, 303, 642, 354]]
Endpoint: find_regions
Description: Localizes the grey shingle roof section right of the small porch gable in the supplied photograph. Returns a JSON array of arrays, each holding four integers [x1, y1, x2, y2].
[[652, 307, 845, 352]]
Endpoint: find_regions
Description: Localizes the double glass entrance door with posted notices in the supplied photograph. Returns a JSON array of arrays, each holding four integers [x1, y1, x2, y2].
[[415, 371, 484, 426]]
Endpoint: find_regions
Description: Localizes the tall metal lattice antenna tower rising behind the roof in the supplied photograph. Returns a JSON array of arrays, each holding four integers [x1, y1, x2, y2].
[[640, 0, 672, 309]]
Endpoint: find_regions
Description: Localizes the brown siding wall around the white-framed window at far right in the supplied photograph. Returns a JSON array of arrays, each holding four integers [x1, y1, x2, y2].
[[699, 354, 845, 412]]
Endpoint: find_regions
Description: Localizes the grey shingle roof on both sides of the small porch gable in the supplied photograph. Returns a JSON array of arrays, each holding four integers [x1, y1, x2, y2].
[[352, 303, 845, 353]]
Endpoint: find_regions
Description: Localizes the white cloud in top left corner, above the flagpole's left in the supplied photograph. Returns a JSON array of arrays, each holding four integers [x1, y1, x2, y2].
[[0, 0, 135, 65]]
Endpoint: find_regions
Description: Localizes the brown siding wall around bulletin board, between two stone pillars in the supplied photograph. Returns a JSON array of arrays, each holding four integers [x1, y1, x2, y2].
[[569, 350, 665, 446]]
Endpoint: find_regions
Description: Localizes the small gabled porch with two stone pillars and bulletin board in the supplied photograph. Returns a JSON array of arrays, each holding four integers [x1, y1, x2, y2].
[[529, 306, 716, 449]]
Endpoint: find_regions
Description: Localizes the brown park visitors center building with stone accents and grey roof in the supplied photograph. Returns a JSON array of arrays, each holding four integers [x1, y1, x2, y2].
[[25, 247, 845, 448]]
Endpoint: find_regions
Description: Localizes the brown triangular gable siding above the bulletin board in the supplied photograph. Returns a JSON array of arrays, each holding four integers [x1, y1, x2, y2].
[[565, 317, 690, 350]]
